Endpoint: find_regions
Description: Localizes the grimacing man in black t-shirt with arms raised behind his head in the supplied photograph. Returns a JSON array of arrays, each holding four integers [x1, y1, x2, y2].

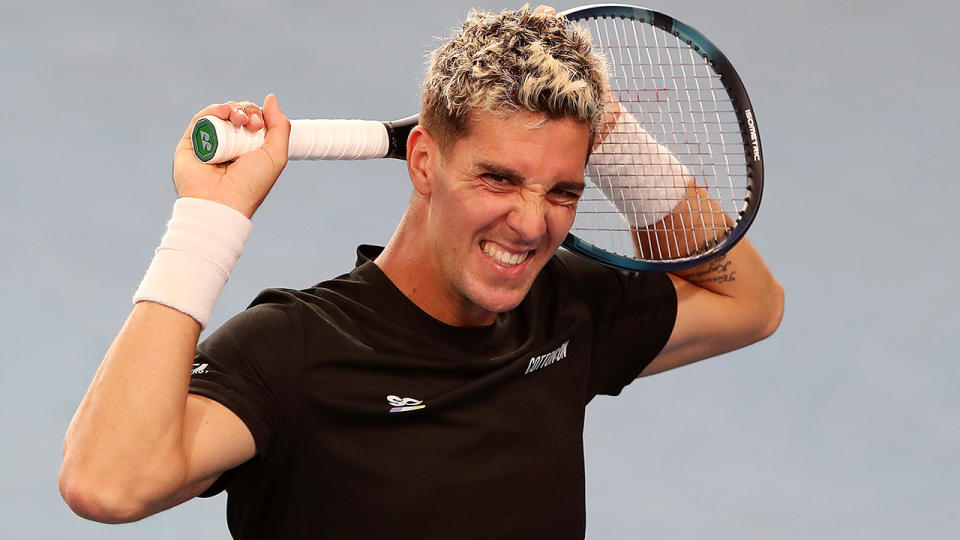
[[60, 7, 782, 538]]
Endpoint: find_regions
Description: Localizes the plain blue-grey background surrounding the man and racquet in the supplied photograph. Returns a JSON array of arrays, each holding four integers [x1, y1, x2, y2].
[[0, 0, 960, 539]]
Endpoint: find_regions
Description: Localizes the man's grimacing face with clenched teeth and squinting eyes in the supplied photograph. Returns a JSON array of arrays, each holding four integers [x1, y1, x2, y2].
[[427, 107, 590, 324]]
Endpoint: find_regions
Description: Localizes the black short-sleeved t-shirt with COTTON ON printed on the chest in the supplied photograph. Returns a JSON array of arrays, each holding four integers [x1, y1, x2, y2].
[[190, 246, 677, 539]]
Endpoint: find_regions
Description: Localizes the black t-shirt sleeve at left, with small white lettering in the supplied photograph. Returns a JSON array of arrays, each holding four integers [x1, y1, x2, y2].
[[190, 290, 304, 497]]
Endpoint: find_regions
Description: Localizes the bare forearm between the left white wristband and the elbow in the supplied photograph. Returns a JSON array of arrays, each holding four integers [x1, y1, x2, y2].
[[61, 302, 200, 515]]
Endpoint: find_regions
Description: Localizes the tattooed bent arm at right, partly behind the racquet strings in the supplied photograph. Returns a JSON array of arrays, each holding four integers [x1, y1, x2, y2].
[[595, 94, 784, 376]]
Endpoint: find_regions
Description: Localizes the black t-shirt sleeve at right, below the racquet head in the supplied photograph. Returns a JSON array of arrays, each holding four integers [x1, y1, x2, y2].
[[559, 252, 677, 401]]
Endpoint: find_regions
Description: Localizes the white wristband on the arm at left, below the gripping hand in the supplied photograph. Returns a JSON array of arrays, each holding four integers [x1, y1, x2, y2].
[[133, 197, 253, 328]]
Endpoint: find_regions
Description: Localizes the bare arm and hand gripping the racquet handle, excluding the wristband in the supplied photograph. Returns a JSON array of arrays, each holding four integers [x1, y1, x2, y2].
[[59, 96, 290, 523]]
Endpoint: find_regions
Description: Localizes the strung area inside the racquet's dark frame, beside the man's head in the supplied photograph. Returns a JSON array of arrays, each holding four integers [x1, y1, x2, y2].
[[571, 14, 749, 261]]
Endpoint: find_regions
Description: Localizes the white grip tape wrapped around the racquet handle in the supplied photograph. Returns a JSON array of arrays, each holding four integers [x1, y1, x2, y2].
[[204, 116, 390, 163]]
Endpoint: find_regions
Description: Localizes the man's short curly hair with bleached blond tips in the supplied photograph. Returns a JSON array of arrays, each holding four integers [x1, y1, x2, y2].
[[420, 5, 608, 153]]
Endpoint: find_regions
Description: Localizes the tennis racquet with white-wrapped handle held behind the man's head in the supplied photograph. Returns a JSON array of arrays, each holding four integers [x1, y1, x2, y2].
[[192, 4, 763, 271]]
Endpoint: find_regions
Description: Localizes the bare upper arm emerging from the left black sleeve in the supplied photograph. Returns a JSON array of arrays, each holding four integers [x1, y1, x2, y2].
[[154, 394, 256, 512]]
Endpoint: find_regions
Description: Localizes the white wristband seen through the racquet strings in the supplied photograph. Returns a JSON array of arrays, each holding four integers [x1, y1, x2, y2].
[[588, 111, 693, 228]]
